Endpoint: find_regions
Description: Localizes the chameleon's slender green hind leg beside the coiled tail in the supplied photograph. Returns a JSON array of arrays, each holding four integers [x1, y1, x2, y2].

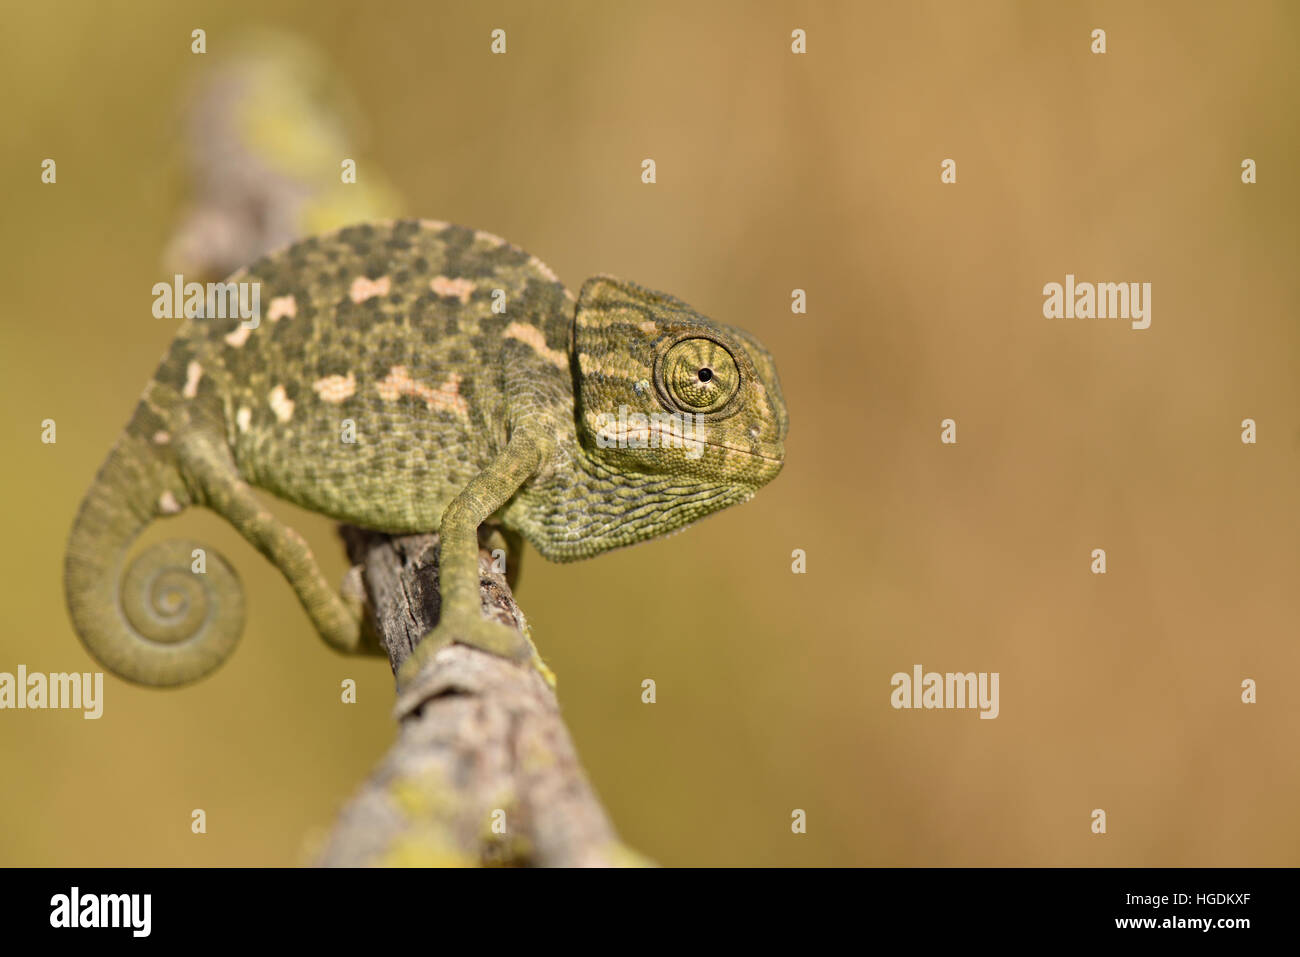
[[177, 439, 380, 653]]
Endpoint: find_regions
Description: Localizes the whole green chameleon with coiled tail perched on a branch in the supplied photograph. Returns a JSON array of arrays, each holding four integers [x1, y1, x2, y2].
[[64, 220, 788, 689]]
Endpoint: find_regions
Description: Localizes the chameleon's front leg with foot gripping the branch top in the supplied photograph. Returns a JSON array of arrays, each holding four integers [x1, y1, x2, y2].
[[398, 432, 546, 692]]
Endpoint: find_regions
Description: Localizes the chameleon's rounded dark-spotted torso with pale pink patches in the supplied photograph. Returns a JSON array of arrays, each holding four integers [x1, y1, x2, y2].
[[157, 221, 573, 532]]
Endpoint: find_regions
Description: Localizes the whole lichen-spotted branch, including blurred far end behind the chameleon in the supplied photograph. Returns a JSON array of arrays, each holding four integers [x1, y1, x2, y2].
[[166, 36, 629, 866]]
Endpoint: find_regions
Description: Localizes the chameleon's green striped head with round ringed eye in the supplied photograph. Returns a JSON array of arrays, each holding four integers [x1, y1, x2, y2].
[[573, 276, 788, 501]]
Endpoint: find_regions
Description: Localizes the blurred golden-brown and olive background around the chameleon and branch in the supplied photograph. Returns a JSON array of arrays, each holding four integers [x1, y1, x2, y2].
[[0, 0, 1300, 866]]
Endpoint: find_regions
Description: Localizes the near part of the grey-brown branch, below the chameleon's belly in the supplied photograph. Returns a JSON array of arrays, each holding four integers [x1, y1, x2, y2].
[[319, 525, 645, 866]]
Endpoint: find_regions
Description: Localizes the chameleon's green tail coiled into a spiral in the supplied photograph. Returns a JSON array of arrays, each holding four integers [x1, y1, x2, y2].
[[64, 426, 243, 685]]
